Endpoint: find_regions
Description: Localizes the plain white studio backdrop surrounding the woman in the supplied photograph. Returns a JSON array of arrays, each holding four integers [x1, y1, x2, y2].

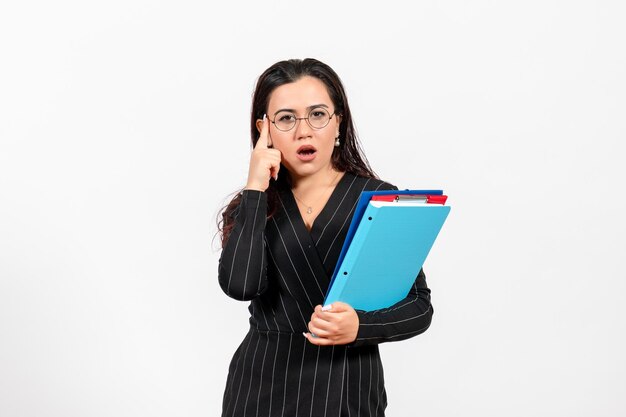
[[0, 0, 626, 417]]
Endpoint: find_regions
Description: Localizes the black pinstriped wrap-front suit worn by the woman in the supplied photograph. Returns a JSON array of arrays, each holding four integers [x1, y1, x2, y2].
[[219, 173, 433, 417]]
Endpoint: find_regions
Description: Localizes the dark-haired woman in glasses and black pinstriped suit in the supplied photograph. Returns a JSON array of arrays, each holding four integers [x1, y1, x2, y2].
[[219, 59, 433, 417]]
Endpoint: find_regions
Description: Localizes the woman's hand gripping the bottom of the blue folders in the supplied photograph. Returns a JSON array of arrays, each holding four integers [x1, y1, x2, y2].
[[304, 302, 359, 346]]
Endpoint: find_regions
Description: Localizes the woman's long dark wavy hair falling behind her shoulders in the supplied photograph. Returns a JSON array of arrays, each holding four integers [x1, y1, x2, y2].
[[218, 58, 378, 247]]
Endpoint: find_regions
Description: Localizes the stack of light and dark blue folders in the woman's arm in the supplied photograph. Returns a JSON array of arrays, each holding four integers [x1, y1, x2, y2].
[[324, 190, 450, 311]]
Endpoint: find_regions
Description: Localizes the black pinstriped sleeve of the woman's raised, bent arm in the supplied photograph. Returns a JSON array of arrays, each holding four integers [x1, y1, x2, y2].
[[218, 190, 267, 301]]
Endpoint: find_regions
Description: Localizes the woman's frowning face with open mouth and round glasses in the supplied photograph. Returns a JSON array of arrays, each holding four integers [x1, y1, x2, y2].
[[257, 76, 341, 178]]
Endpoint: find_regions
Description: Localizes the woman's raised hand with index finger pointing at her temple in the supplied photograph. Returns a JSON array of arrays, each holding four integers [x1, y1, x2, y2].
[[246, 116, 281, 191]]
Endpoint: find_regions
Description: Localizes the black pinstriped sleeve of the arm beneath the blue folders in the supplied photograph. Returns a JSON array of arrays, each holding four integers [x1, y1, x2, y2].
[[349, 270, 433, 347]]
